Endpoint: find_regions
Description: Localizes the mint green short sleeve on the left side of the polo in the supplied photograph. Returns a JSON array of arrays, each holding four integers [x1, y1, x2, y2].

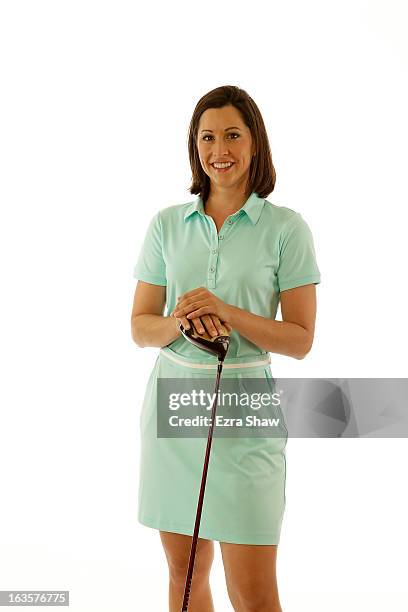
[[133, 211, 167, 285]]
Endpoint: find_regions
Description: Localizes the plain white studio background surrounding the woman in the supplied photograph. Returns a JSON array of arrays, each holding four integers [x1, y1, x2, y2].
[[0, 0, 408, 612]]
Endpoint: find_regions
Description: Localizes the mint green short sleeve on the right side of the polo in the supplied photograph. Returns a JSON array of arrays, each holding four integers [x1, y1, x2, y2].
[[277, 213, 320, 291]]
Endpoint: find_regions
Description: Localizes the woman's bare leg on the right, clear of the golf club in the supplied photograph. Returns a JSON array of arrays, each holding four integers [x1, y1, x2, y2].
[[220, 542, 282, 612]]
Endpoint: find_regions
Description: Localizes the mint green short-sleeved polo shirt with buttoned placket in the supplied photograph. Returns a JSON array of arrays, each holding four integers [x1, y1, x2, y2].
[[133, 192, 320, 361]]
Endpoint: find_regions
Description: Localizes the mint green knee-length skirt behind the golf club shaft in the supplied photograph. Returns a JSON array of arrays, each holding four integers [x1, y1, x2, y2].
[[138, 347, 287, 544]]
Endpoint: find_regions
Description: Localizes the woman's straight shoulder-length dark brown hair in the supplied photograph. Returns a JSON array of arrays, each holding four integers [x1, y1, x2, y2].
[[188, 85, 276, 202]]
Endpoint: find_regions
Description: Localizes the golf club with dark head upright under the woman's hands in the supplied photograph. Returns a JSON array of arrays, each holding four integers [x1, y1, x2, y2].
[[179, 323, 230, 612]]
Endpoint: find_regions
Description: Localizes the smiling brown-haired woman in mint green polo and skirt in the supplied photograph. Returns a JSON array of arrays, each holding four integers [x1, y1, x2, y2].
[[132, 86, 320, 612]]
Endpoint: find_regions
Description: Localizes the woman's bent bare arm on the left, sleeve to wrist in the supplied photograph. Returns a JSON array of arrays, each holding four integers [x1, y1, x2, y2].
[[131, 280, 181, 348]]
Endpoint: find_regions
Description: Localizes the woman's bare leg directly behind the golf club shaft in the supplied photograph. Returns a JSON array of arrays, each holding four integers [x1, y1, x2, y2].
[[160, 531, 214, 612]]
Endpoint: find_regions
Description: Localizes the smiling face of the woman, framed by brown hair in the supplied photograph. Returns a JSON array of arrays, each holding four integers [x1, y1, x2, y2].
[[197, 104, 255, 192]]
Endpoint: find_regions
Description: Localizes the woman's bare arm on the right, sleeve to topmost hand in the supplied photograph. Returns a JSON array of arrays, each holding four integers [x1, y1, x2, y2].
[[171, 284, 316, 359]]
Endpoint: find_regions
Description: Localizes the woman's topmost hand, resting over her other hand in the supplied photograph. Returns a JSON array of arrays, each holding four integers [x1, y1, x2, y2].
[[170, 287, 231, 323]]
